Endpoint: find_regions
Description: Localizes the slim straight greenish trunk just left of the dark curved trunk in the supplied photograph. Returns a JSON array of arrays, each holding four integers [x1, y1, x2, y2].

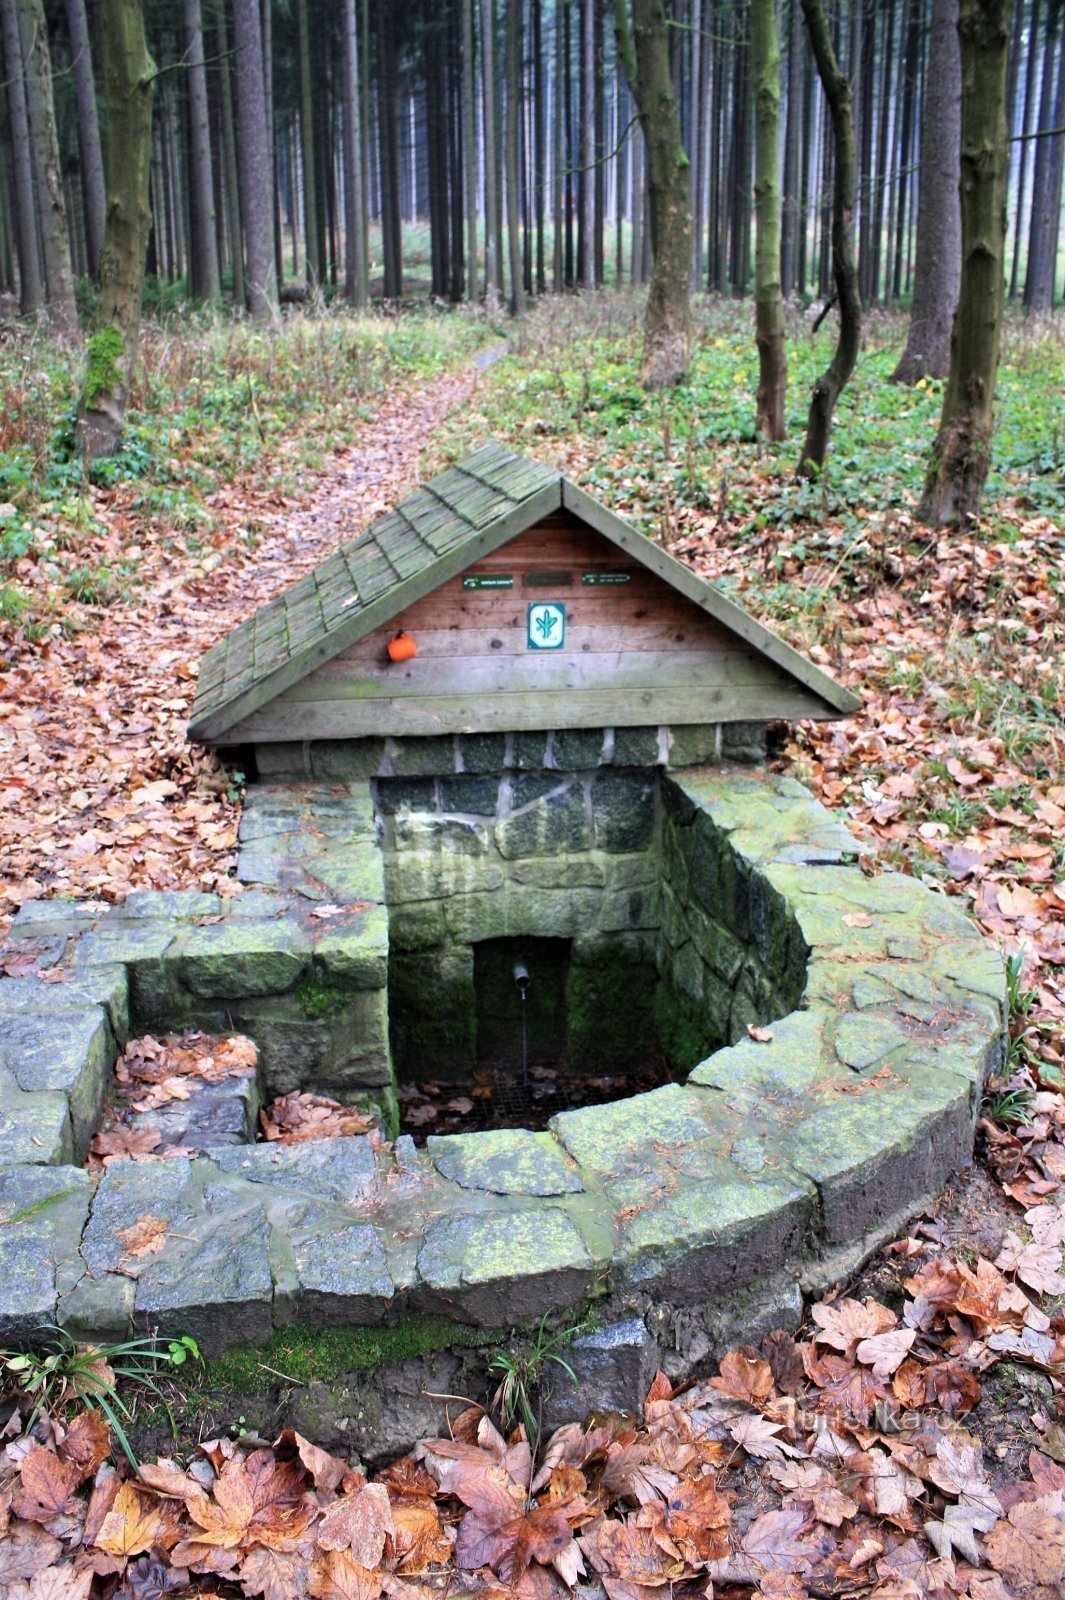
[[750, 0, 788, 438]]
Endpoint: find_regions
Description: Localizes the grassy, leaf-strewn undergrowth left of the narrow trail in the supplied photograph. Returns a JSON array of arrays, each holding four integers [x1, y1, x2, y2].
[[0, 307, 499, 637]]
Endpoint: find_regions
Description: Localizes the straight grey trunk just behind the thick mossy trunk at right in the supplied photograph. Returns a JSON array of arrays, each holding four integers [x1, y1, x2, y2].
[[891, 0, 961, 384]]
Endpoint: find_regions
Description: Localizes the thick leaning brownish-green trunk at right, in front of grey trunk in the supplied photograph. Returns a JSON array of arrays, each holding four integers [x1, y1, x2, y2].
[[918, 0, 1011, 528]]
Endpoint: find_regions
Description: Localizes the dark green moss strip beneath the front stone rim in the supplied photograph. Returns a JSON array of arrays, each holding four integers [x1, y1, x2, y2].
[[203, 1315, 505, 1395]]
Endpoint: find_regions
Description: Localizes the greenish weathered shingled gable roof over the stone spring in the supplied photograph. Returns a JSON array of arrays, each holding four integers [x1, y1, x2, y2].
[[189, 443, 860, 744]]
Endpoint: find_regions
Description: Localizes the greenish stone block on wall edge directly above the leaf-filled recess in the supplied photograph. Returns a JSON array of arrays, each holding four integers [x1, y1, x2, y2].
[[173, 922, 310, 1000]]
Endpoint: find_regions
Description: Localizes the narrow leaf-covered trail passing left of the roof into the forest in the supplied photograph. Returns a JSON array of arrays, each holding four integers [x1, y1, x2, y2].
[[0, 362, 483, 931]]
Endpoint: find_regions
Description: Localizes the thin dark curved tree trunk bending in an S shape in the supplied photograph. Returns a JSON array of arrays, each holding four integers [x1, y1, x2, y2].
[[796, 0, 862, 478]]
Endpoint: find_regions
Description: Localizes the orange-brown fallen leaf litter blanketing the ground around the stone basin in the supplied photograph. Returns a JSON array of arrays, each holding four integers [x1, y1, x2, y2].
[[0, 302, 1065, 1600]]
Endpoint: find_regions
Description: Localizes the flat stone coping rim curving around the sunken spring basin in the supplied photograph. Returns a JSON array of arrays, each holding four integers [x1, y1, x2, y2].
[[0, 770, 1004, 1358]]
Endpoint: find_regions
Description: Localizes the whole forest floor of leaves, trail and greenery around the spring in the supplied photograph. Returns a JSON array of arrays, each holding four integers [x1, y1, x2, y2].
[[0, 294, 1065, 1600]]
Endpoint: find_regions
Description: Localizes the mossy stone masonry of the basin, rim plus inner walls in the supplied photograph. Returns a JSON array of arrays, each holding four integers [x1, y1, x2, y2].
[[0, 774, 1006, 1363]]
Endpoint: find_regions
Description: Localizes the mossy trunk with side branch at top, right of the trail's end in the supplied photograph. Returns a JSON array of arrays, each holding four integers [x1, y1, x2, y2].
[[614, 0, 691, 389]]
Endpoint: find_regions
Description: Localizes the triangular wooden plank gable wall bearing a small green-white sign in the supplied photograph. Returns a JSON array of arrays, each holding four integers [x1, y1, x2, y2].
[[225, 510, 820, 739]]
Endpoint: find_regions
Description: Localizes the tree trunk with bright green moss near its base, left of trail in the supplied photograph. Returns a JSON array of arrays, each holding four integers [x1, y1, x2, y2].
[[78, 0, 155, 461]]
